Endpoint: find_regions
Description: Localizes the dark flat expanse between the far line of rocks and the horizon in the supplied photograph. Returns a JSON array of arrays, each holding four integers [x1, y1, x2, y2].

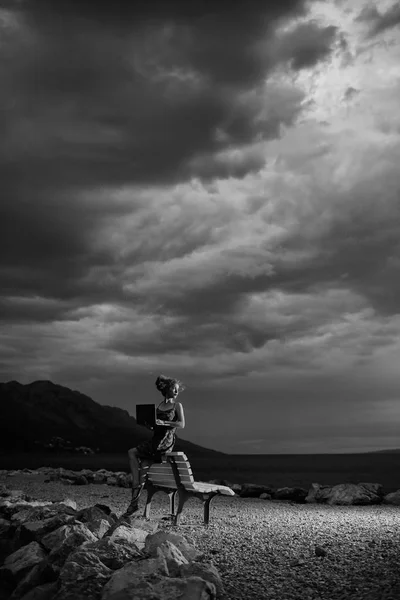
[[0, 453, 400, 493]]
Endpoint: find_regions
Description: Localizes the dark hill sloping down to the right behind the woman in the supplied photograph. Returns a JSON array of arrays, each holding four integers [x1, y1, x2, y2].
[[0, 381, 219, 455]]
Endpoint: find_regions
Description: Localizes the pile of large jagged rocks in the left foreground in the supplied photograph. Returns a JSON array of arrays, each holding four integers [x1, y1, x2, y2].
[[0, 486, 223, 600]]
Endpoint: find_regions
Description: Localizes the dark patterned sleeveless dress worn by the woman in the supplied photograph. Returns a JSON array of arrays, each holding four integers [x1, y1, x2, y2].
[[137, 403, 177, 463]]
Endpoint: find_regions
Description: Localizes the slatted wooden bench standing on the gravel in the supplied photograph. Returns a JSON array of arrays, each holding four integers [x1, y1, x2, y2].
[[144, 452, 235, 525]]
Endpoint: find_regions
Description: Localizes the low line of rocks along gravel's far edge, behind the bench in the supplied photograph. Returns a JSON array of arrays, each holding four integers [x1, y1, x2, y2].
[[0, 467, 400, 506]]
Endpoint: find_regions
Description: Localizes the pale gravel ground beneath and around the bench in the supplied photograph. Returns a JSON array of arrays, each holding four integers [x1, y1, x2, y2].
[[0, 476, 400, 600]]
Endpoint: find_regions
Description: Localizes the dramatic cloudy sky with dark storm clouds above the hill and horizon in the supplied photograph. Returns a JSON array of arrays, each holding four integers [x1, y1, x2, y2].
[[0, 0, 400, 453]]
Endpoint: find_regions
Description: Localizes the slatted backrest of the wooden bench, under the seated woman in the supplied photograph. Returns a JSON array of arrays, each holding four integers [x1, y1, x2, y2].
[[147, 452, 194, 490]]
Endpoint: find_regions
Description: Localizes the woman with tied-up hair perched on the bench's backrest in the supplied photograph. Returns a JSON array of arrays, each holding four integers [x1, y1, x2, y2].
[[125, 375, 185, 515]]
